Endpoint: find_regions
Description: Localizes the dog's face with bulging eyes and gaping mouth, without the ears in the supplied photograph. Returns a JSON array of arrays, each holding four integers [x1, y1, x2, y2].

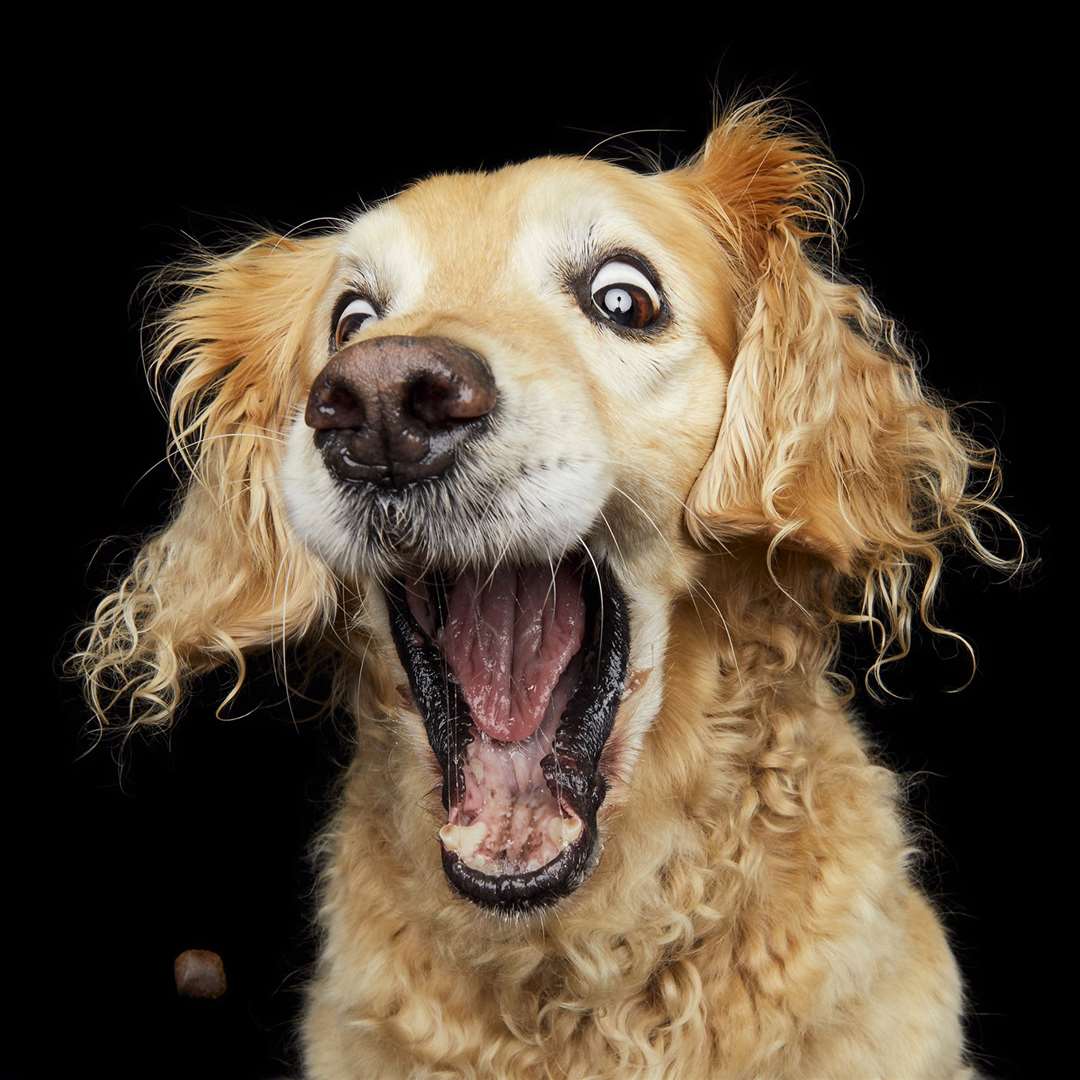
[[281, 159, 734, 912]]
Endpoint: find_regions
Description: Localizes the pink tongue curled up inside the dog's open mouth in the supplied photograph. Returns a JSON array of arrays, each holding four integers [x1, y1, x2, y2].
[[441, 567, 585, 742]]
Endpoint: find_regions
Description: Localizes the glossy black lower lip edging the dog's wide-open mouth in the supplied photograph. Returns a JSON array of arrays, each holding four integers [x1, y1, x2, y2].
[[384, 564, 630, 914]]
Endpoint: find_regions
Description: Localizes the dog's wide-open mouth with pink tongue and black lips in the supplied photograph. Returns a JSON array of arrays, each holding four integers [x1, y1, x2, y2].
[[386, 555, 630, 913]]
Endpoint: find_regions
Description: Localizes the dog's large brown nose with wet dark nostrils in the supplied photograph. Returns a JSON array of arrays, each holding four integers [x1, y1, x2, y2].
[[303, 337, 496, 487]]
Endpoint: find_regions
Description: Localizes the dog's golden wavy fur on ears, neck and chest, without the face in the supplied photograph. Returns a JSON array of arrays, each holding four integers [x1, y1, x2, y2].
[[76, 102, 1018, 1080]]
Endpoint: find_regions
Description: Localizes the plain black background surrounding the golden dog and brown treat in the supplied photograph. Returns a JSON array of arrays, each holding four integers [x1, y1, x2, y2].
[[16, 25, 1062, 1078]]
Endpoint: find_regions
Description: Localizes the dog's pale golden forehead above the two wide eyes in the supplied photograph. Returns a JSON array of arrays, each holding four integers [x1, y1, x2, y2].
[[332, 157, 708, 300]]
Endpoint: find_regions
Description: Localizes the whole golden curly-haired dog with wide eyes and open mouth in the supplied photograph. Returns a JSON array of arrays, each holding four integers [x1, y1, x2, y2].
[[77, 99, 1008, 1080]]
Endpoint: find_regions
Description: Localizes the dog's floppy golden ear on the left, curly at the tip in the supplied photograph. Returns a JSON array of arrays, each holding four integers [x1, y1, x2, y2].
[[73, 235, 335, 724]]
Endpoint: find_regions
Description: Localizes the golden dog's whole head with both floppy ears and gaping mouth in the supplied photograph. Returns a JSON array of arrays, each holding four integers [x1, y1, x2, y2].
[[82, 106, 1010, 912]]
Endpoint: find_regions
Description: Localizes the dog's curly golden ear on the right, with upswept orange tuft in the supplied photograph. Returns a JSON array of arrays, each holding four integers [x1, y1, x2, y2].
[[676, 102, 1023, 674]]
